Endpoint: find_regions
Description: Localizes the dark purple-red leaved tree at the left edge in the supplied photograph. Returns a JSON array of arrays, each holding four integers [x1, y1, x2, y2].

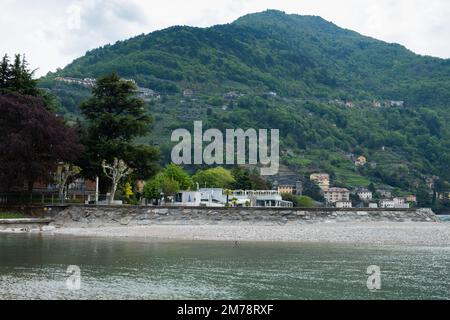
[[0, 94, 83, 193]]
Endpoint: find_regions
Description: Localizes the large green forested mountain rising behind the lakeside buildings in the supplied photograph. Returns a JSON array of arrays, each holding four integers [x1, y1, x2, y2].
[[40, 10, 450, 192]]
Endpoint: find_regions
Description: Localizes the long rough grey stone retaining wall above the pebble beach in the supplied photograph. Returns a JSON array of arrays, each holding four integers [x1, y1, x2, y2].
[[48, 206, 439, 227]]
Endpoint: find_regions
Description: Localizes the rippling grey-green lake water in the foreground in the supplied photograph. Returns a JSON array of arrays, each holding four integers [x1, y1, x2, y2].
[[0, 234, 450, 299]]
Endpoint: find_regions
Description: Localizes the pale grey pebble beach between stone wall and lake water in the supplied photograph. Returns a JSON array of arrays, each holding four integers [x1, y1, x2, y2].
[[41, 222, 450, 247]]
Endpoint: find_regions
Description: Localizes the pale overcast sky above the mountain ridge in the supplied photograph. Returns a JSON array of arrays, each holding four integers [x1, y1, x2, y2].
[[0, 0, 450, 75]]
